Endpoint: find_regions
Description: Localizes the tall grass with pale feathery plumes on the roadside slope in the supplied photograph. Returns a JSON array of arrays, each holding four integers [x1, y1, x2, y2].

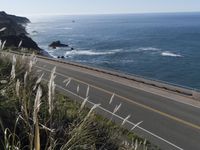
[[0, 52, 156, 150]]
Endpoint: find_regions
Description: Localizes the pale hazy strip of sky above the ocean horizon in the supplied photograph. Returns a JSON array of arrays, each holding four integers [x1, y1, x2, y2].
[[0, 0, 200, 15]]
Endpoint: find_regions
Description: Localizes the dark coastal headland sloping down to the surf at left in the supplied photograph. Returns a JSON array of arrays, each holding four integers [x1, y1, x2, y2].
[[0, 11, 51, 57]]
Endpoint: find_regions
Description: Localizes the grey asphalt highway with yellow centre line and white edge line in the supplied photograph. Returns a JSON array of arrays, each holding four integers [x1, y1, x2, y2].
[[1, 52, 200, 150]]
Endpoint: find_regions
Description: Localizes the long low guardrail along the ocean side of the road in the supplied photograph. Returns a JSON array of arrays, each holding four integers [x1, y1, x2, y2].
[[0, 51, 200, 96]]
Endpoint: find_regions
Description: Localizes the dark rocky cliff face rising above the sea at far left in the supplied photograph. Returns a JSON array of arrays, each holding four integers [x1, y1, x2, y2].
[[0, 11, 40, 50]]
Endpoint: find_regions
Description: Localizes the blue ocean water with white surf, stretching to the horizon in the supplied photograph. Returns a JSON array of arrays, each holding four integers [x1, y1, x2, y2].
[[28, 13, 200, 89]]
